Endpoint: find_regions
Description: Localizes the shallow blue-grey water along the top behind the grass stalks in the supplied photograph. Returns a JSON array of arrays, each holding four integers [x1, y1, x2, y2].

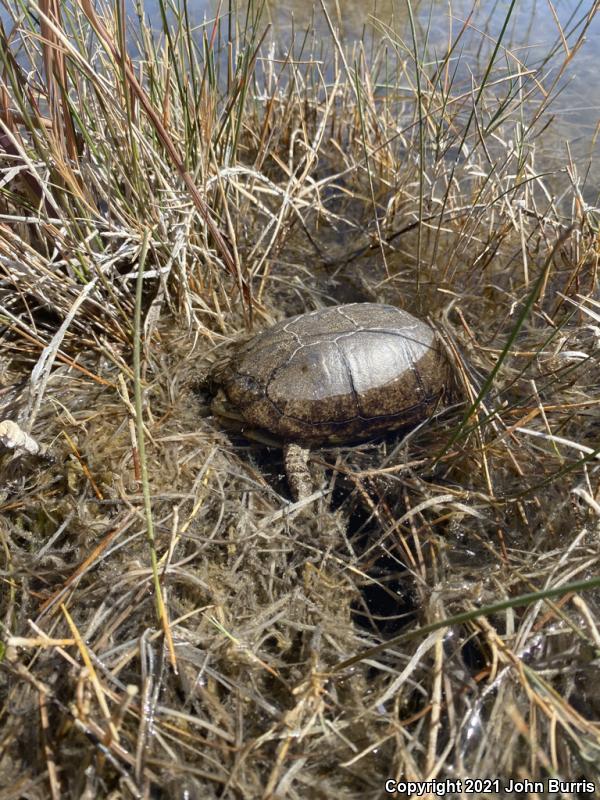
[[0, 0, 600, 197]]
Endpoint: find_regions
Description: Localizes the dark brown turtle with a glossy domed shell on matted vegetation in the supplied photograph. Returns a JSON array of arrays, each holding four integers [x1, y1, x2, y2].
[[210, 303, 448, 500]]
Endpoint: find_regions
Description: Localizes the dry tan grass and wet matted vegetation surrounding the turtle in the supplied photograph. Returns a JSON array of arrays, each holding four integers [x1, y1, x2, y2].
[[0, 0, 600, 800]]
